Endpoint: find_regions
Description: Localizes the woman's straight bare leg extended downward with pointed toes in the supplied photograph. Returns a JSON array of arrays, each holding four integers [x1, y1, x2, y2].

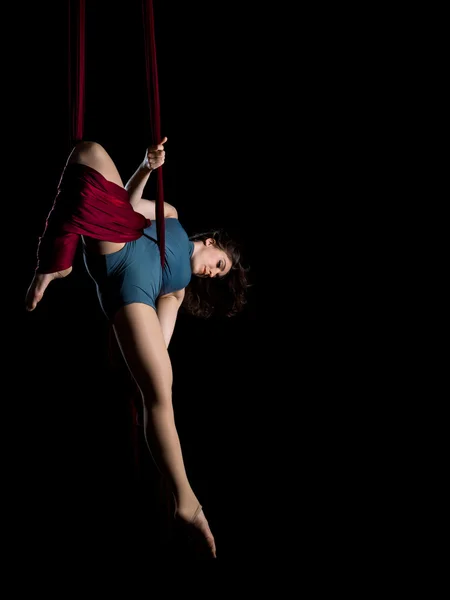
[[114, 303, 215, 556]]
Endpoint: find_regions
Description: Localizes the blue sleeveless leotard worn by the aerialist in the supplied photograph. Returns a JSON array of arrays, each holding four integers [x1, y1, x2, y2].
[[83, 219, 194, 320]]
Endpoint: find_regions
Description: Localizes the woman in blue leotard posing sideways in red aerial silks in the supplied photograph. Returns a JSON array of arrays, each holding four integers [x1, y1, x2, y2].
[[26, 138, 247, 557]]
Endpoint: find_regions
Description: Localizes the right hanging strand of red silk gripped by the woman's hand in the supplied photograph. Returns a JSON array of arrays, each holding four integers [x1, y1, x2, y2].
[[142, 0, 165, 265]]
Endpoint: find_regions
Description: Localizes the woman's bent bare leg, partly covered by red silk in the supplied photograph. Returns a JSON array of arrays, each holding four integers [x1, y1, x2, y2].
[[25, 142, 125, 311]]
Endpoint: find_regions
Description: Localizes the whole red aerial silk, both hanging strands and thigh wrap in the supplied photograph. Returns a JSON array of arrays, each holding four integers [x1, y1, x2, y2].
[[36, 0, 165, 273]]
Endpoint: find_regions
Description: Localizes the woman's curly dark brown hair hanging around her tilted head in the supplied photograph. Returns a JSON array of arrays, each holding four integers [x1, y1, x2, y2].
[[182, 229, 250, 319]]
